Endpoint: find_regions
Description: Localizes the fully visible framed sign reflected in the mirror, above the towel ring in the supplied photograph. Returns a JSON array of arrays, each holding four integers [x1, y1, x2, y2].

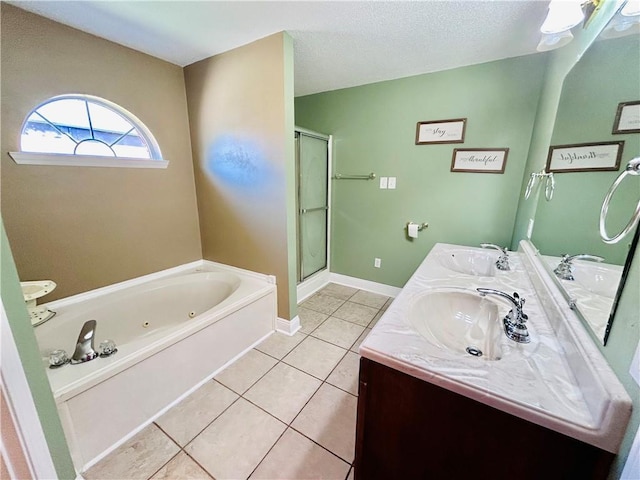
[[546, 142, 624, 173]]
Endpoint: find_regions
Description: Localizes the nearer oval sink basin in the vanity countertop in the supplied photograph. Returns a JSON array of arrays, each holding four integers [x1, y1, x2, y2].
[[409, 290, 503, 360]]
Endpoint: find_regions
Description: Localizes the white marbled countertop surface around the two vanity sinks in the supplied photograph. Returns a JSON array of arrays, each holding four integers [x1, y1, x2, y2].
[[360, 244, 630, 451]]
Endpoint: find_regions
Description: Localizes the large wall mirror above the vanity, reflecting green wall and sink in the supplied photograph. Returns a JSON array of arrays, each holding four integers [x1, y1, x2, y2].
[[531, 9, 640, 344]]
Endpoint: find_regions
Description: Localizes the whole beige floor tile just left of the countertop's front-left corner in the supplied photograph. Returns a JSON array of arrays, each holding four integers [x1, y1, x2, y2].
[[282, 337, 346, 380]]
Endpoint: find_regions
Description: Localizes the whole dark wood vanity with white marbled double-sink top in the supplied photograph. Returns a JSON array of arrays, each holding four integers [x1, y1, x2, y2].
[[355, 241, 631, 480]]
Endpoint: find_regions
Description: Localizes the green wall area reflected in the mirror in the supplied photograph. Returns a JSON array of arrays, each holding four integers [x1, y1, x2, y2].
[[532, 35, 640, 265]]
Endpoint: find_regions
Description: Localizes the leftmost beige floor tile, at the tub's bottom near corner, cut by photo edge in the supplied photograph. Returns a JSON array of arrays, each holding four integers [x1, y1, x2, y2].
[[82, 424, 180, 480]]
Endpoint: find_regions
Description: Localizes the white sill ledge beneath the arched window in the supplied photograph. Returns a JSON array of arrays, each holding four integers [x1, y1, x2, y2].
[[9, 152, 169, 168]]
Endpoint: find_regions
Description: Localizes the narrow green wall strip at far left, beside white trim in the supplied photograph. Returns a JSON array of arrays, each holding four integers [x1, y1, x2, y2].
[[0, 220, 76, 479]]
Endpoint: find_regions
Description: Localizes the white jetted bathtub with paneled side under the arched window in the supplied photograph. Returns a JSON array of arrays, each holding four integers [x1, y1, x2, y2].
[[35, 261, 276, 472]]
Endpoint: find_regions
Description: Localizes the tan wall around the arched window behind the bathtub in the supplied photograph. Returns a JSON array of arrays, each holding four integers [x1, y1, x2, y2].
[[0, 3, 202, 300]]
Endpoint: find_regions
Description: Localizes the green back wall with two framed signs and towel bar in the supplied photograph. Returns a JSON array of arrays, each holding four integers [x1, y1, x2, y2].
[[295, 55, 545, 287]]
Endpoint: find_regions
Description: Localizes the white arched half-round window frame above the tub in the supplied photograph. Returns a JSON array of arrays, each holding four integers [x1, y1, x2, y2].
[[8, 93, 169, 168]]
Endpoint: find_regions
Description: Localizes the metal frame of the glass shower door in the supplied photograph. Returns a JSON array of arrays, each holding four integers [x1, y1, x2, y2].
[[294, 127, 333, 286]]
